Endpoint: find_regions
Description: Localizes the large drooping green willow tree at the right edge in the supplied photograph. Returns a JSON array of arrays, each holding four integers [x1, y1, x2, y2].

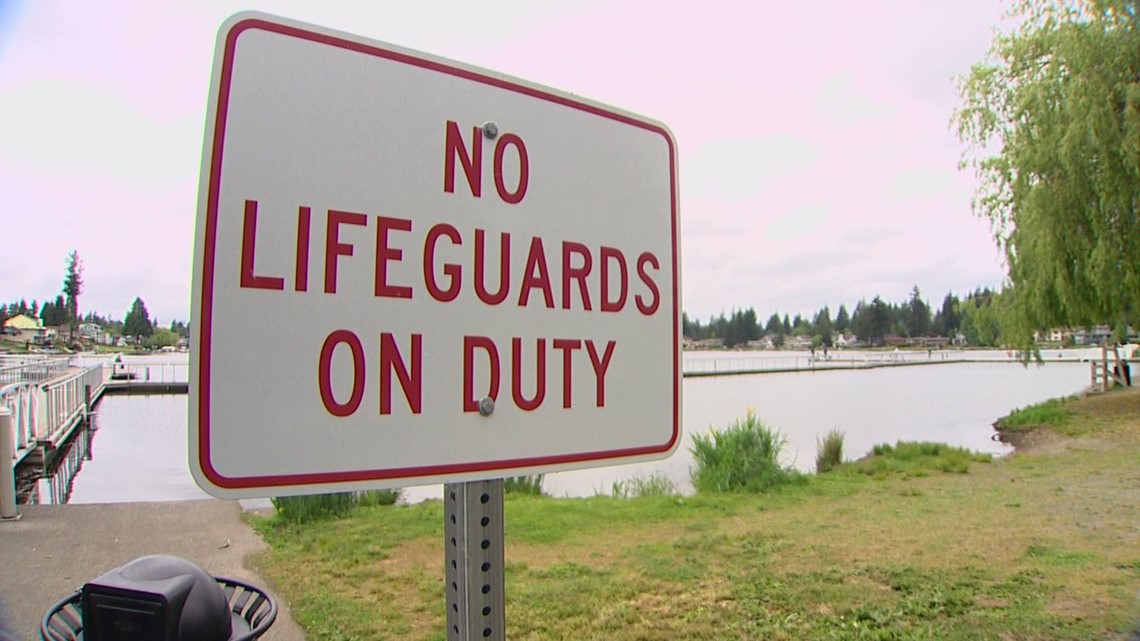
[[954, 0, 1140, 347]]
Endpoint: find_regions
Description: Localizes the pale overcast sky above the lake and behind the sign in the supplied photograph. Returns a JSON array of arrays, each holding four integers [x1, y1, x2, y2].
[[0, 0, 1005, 324]]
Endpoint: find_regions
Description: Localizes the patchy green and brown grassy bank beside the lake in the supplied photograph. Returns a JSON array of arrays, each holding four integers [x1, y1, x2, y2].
[[254, 390, 1140, 640]]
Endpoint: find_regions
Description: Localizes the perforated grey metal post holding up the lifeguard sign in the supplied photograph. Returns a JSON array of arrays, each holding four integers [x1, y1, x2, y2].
[[443, 479, 506, 641]]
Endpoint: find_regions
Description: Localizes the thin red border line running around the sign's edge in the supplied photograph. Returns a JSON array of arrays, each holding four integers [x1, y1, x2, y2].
[[195, 18, 682, 490]]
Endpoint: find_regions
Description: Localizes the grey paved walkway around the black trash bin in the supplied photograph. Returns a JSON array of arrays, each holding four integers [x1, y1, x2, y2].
[[0, 500, 304, 641]]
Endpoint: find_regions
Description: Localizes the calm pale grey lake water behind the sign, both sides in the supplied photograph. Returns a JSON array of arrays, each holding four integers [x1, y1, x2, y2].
[[40, 350, 1099, 503]]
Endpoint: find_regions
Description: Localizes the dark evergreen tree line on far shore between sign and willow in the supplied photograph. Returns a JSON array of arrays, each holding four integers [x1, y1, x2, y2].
[[682, 285, 1000, 347]]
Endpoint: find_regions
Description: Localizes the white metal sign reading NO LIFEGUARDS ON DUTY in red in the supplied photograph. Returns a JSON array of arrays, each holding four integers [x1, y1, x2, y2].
[[189, 14, 682, 496]]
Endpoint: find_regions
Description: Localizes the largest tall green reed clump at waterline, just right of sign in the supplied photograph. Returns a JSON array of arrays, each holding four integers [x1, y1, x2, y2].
[[690, 409, 806, 493]]
